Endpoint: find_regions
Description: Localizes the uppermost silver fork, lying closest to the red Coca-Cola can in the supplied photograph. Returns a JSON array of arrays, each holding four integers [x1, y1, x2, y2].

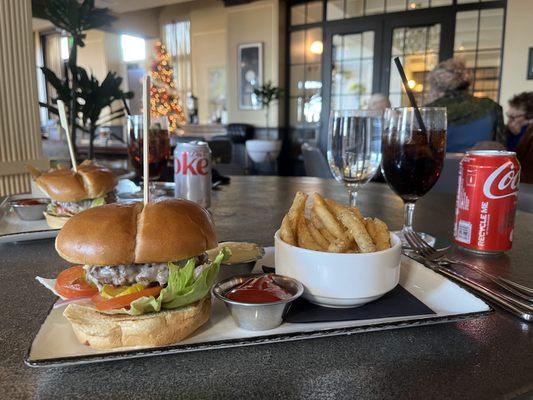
[[404, 231, 533, 302]]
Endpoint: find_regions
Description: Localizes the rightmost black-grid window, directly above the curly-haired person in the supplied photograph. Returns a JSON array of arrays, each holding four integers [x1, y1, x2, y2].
[[454, 8, 504, 101]]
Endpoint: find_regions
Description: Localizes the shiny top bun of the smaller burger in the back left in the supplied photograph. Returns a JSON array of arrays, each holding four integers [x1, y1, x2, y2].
[[28, 160, 117, 201]]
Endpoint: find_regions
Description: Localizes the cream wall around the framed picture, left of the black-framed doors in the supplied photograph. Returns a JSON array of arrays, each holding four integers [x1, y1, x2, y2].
[[159, 0, 280, 127]]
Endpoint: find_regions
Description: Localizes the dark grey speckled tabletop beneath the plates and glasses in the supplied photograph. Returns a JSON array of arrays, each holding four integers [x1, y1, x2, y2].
[[0, 177, 533, 400]]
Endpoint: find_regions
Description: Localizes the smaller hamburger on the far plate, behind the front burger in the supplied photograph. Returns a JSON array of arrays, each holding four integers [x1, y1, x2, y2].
[[28, 160, 117, 229]]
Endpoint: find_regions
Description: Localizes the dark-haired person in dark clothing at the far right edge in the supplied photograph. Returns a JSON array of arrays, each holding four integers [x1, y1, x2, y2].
[[507, 92, 533, 183]]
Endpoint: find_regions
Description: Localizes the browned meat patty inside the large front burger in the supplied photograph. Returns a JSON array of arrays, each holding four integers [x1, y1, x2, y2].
[[85, 253, 207, 289]]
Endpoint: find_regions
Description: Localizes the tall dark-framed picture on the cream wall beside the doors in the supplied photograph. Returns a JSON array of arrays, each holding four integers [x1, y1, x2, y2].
[[237, 43, 263, 110]]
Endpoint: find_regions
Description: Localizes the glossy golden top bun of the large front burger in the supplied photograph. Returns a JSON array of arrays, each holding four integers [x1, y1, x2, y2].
[[56, 199, 218, 265]]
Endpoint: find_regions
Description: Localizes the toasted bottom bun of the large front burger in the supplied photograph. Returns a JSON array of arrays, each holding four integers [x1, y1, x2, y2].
[[63, 296, 211, 349]]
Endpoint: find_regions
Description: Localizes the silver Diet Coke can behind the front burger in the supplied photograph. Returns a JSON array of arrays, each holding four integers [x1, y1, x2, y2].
[[174, 141, 211, 208]]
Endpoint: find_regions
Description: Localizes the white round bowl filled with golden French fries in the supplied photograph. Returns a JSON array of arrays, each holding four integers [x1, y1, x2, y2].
[[274, 192, 401, 307]]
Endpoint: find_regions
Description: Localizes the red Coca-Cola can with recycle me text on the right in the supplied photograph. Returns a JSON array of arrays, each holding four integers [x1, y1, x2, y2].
[[454, 150, 520, 253]]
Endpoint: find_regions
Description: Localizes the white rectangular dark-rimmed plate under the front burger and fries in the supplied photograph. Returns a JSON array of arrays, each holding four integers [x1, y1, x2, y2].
[[25, 252, 491, 367]]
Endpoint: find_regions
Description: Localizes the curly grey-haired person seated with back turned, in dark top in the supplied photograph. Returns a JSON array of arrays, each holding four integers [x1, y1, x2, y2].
[[427, 58, 506, 152]]
